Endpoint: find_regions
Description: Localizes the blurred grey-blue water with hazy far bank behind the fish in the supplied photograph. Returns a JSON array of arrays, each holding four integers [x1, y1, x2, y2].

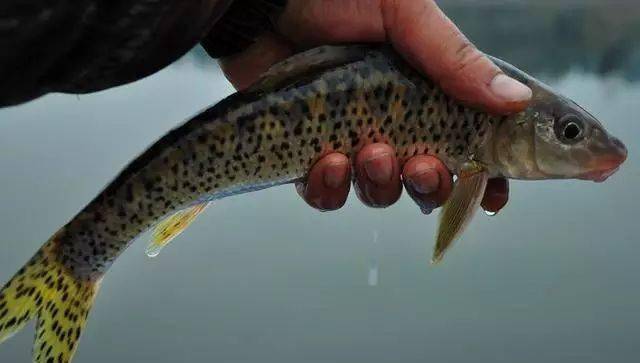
[[0, 0, 640, 363]]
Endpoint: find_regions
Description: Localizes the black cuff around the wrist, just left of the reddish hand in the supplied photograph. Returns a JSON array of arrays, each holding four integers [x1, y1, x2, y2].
[[201, 0, 287, 58]]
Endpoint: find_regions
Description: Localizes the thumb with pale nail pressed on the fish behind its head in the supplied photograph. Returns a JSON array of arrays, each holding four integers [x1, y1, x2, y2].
[[381, 0, 532, 114]]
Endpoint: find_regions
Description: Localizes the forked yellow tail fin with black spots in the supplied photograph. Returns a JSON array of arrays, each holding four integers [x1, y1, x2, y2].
[[0, 239, 99, 363]]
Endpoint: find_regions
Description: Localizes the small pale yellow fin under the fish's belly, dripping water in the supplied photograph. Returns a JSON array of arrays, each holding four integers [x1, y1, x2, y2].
[[146, 202, 210, 257]]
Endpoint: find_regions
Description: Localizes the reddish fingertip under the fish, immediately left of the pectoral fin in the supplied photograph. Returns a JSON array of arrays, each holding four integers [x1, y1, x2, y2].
[[402, 155, 453, 214]]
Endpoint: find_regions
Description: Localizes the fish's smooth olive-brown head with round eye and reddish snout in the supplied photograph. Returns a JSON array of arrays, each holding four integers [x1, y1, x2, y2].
[[494, 56, 627, 182]]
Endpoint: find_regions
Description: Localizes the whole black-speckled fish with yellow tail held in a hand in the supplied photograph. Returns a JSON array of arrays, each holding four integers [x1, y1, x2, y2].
[[0, 46, 627, 363]]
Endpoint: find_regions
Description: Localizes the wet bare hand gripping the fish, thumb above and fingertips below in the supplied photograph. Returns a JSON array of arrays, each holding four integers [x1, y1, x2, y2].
[[222, 0, 531, 212]]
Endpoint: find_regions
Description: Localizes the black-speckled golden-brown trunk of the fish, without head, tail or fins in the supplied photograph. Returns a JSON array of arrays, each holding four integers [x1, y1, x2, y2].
[[55, 44, 493, 279]]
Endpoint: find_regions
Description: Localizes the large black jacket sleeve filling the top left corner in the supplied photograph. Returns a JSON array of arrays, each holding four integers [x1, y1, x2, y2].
[[0, 0, 233, 107]]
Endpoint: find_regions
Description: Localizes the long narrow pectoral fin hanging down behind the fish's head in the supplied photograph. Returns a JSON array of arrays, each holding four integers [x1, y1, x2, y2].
[[431, 162, 488, 264]]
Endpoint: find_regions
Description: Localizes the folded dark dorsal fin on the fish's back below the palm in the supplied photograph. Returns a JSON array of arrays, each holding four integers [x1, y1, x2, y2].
[[248, 45, 371, 93]]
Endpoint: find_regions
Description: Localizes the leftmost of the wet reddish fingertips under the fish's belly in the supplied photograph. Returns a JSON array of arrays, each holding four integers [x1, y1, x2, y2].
[[296, 153, 351, 211]]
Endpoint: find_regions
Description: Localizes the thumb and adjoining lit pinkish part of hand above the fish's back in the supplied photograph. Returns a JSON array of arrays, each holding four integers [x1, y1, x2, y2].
[[278, 0, 532, 114]]
